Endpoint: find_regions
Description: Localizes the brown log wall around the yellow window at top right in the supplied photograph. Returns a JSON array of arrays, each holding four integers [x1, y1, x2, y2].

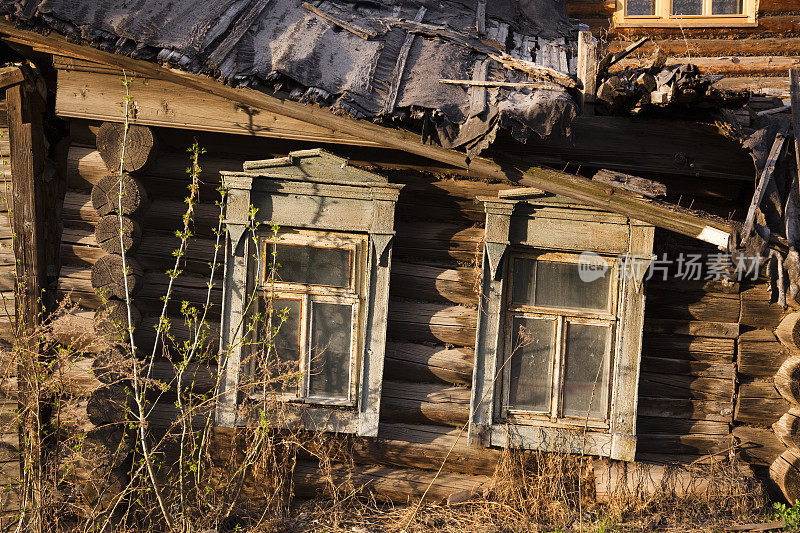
[[567, 0, 800, 96]]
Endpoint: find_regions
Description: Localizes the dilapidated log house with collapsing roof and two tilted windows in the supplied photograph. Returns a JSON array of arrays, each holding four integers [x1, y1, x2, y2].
[[0, 0, 800, 520]]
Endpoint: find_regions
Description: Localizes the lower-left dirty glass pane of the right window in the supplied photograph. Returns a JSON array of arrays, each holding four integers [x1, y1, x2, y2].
[[507, 317, 556, 413]]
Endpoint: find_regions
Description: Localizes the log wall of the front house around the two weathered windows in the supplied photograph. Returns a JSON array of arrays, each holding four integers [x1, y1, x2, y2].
[[59, 115, 788, 500]]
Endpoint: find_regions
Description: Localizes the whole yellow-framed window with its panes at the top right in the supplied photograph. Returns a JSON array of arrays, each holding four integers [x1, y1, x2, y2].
[[614, 0, 758, 28]]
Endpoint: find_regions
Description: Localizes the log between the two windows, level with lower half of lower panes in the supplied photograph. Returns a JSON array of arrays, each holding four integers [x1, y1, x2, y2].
[[383, 342, 475, 386]]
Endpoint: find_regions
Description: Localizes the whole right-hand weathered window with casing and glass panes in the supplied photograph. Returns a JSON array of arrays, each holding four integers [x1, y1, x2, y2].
[[470, 196, 653, 460]]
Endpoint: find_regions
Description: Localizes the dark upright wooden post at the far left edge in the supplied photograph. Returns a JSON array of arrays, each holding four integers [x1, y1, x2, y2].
[[6, 64, 47, 531]]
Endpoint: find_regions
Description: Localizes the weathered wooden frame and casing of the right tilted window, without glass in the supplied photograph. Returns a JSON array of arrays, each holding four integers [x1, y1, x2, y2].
[[469, 197, 654, 461]]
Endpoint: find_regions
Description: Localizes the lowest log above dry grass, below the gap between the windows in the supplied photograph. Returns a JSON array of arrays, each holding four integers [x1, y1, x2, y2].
[[292, 461, 490, 503]]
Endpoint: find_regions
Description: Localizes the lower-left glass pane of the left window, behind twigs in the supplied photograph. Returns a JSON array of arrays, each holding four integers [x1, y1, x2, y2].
[[262, 298, 302, 391]]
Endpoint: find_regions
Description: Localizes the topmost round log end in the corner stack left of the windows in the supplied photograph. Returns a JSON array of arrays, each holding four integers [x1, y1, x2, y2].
[[96, 122, 158, 173]]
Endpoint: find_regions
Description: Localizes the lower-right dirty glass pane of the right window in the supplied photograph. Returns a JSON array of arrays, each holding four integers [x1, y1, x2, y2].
[[562, 322, 611, 420]]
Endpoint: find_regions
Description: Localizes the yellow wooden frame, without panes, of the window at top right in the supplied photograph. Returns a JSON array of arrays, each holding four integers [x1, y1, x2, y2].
[[614, 0, 758, 28]]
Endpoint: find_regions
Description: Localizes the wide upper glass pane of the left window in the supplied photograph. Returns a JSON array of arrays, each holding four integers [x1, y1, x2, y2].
[[274, 242, 350, 287]]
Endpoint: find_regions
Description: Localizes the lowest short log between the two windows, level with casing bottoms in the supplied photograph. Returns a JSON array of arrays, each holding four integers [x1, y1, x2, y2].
[[381, 381, 470, 427]]
